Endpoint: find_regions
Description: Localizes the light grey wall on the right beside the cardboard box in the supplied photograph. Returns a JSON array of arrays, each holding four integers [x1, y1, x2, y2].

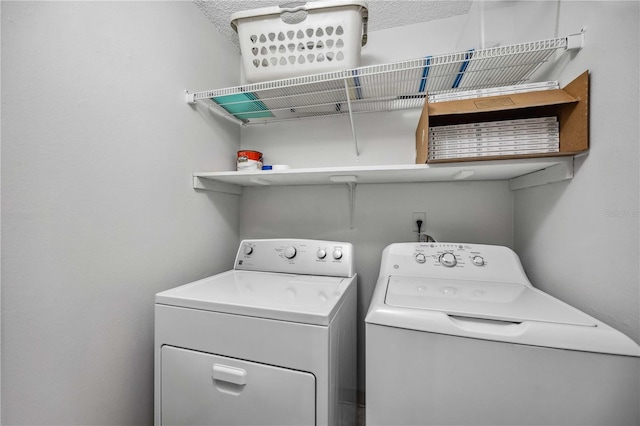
[[514, 1, 640, 342]]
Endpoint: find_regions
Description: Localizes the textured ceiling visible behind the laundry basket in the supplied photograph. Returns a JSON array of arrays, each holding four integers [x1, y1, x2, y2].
[[194, 0, 472, 51]]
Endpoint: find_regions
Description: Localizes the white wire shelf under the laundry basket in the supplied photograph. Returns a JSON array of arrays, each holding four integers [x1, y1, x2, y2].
[[187, 36, 572, 125]]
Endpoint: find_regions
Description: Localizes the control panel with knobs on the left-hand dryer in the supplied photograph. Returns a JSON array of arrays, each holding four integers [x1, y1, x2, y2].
[[234, 239, 355, 277]]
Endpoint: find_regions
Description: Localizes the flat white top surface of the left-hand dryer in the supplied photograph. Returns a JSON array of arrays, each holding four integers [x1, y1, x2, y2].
[[156, 271, 355, 325]]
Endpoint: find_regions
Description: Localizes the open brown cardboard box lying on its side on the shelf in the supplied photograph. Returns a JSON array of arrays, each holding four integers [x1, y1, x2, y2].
[[416, 71, 589, 164]]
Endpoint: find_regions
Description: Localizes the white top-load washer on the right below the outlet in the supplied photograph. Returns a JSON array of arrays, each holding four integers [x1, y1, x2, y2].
[[365, 243, 640, 426]]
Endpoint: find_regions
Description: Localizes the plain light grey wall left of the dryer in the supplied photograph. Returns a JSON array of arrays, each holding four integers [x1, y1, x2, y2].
[[1, 1, 239, 425]]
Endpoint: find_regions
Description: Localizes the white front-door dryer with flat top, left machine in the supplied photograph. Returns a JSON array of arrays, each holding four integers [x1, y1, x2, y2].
[[155, 239, 357, 426]]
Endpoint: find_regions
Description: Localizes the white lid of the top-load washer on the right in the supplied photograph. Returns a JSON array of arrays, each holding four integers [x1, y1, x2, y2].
[[385, 276, 597, 327]]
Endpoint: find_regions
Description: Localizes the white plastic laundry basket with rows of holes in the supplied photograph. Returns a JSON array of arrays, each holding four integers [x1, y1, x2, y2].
[[231, 0, 368, 83]]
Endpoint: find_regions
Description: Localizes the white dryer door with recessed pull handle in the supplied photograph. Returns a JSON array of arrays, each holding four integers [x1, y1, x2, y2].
[[160, 346, 315, 426]]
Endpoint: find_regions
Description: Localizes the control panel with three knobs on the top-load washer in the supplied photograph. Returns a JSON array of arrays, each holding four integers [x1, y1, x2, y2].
[[380, 243, 526, 282]]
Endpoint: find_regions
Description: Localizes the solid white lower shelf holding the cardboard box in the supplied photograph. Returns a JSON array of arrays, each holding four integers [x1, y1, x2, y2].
[[194, 156, 573, 194]]
